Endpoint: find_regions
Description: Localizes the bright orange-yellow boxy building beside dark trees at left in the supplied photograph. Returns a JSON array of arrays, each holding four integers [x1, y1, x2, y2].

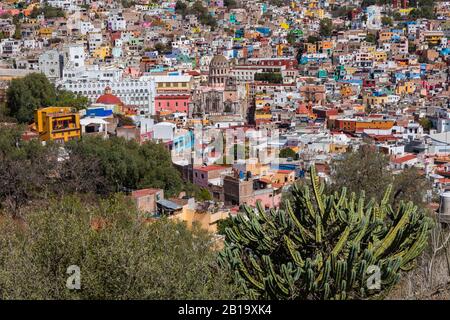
[[34, 107, 81, 142]]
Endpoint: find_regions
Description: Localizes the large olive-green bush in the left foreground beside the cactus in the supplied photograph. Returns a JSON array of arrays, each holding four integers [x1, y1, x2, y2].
[[0, 196, 243, 300]]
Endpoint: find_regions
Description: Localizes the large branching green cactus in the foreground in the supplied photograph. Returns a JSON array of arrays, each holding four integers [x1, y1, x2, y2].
[[219, 166, 432, 299]]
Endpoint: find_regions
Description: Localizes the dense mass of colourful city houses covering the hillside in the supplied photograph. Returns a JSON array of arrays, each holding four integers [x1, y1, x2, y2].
[[0, 0, 450, 229]]
